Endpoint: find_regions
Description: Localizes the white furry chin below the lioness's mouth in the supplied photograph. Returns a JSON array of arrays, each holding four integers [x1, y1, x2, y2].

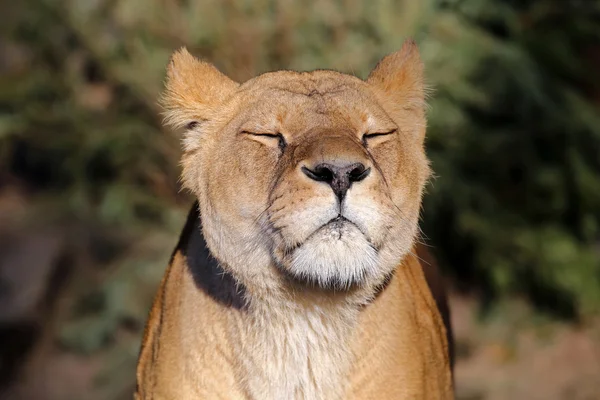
[[288, 222, 378, 289]]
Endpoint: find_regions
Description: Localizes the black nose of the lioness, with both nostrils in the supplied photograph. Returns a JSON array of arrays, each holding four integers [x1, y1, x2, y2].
[[302, 163, 371, 202]]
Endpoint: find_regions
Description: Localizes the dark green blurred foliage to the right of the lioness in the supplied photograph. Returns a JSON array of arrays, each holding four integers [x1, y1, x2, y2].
[[425, 0, 600, 316]]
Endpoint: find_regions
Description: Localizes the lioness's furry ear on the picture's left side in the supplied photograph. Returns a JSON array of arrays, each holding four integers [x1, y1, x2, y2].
[[161, 47, 239, 127]]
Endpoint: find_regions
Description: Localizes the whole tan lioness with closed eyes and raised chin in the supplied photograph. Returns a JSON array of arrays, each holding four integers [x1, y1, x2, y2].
[[136, 41, 452, 400]]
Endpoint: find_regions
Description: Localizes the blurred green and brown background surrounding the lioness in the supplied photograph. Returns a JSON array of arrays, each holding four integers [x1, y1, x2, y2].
[[0, 0, 600, 400]]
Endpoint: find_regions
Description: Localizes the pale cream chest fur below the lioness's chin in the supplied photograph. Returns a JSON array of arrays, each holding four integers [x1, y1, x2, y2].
[[232, 307, 356, 400]]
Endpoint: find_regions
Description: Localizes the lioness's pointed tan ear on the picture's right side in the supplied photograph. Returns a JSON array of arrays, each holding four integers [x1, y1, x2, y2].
[[367, 39, 425, 112]]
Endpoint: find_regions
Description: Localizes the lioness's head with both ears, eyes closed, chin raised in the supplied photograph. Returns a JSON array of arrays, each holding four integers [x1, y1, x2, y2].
[[163, 41, 429, 296]]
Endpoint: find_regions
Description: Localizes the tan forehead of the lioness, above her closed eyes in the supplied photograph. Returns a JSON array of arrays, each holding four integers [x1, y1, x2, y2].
[[234, 71, 391, 130]]
